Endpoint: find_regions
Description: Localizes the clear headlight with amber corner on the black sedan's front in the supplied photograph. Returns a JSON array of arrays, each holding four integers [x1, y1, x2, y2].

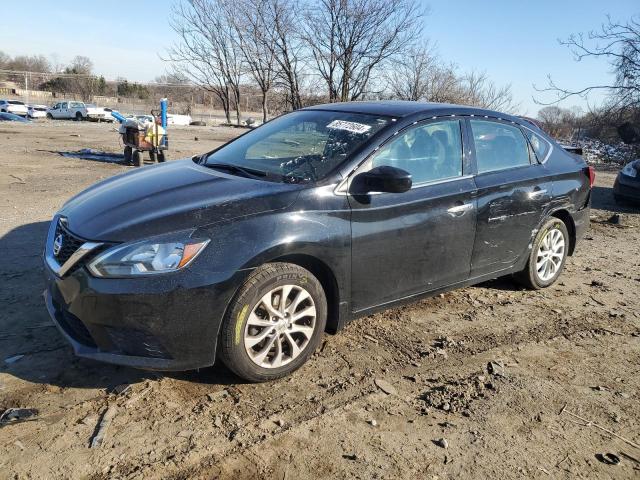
[[88, 238, 209, 277]]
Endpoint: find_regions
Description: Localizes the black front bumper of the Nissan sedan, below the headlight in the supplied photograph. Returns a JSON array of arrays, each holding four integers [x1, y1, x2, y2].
[[44, 255, 242, 371]]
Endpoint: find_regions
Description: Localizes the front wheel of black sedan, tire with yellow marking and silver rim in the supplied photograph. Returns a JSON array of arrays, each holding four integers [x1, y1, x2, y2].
[[218, 263, 327, 382]]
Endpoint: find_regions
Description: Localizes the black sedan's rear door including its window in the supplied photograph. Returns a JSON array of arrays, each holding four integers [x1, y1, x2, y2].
[[467, 119, 552, 277]]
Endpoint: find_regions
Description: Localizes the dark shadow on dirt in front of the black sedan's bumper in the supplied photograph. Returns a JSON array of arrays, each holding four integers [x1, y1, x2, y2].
[[0, 222, 241, 390]]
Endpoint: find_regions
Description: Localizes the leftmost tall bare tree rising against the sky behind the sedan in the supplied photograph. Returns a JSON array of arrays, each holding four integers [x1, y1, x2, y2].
[[166, 0, 243, 124]]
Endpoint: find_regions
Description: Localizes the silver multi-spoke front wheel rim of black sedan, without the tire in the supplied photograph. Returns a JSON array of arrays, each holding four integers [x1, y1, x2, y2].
[[244, 285, 316, 368]]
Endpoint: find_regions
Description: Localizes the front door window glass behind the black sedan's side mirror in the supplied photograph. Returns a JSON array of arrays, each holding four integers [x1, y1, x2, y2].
[[371, 120, 462, 185]]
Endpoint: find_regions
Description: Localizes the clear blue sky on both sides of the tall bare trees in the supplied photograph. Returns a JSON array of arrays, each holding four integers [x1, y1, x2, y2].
[[0, 0, 640, 115]]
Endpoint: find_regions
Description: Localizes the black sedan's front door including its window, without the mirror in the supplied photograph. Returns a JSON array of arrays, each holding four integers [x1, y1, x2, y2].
[[349, 118, 476, 311]]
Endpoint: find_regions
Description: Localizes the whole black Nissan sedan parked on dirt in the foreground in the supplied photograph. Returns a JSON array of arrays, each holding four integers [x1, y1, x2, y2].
[[44, 102, 594, 381]]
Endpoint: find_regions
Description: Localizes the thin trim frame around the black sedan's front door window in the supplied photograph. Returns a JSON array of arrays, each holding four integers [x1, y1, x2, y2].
[[333, 115, 468, 196]]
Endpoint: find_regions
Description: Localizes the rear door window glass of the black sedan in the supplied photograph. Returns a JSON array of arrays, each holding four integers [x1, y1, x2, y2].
[[471, 120, 530, 173]]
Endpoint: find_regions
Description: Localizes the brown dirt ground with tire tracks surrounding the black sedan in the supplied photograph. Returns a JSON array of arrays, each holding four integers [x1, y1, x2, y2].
[[0, 121, 640, 479]]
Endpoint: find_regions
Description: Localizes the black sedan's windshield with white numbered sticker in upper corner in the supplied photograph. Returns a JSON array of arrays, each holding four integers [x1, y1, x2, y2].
[[204, 110, 391, 183]]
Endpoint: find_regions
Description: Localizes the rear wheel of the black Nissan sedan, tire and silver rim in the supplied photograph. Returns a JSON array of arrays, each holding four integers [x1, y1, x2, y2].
[[515, 217, 570, 290]]
